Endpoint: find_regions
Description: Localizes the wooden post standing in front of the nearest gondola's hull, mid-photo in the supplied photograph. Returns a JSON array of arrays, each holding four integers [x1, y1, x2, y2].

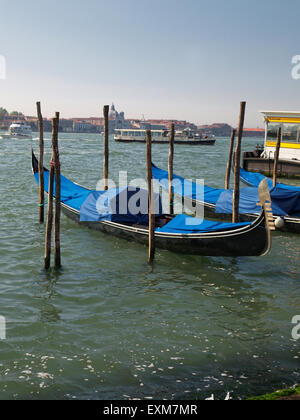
[[146, 130, 155, 264]]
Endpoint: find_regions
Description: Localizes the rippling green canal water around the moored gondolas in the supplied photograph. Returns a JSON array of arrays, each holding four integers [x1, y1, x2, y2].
[[0, 134, 300, 399]]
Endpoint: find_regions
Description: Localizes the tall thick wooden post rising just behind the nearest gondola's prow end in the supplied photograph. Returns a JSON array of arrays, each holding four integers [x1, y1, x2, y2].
[[232, 102, 246, 223]]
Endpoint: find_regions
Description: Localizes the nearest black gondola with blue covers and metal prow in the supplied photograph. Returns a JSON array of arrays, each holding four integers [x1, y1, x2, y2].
[[32, 152, 271, 257]]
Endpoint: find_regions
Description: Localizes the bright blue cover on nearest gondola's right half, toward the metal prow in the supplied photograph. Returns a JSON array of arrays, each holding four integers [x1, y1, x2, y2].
[[156, 214, 251, 234]]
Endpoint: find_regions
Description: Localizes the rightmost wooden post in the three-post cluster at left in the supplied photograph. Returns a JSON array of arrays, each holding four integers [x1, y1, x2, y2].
[[52, 112, 61, 268]]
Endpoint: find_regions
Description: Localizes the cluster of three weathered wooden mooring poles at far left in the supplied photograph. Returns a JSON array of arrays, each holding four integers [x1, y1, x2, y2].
[[36, 102, 61, 270]]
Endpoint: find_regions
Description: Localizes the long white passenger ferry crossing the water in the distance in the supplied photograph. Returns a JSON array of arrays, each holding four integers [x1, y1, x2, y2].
[[115, 129, 216, 146]]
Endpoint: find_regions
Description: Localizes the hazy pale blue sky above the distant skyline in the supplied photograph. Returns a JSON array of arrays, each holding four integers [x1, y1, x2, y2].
[[0, 0, 300, 127]]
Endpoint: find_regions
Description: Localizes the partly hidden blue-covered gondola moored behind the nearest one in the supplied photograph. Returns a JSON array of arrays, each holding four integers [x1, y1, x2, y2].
[[152, 164, 300, 233]]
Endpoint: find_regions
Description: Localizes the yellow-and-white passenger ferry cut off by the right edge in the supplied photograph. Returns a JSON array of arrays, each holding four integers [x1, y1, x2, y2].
[[243, 111, 300, 177]]
